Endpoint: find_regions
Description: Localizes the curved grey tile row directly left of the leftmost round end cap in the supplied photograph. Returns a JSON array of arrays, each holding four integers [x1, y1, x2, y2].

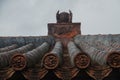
[[0, 43, 33, 68]]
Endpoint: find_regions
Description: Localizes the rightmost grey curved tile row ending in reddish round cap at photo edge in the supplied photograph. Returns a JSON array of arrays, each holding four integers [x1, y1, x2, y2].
[[74, 35, 120, 68]]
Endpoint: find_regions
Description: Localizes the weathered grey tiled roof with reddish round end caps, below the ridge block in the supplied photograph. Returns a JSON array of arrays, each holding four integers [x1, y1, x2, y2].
[[0, 35, 120, 79]]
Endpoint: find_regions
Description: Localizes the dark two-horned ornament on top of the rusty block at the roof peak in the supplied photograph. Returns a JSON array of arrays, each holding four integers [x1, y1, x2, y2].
[[56, 10, 72, 23]]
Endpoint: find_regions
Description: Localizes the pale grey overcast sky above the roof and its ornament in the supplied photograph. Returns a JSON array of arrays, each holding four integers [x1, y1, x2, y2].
[[0, 0, 120, 36]]
